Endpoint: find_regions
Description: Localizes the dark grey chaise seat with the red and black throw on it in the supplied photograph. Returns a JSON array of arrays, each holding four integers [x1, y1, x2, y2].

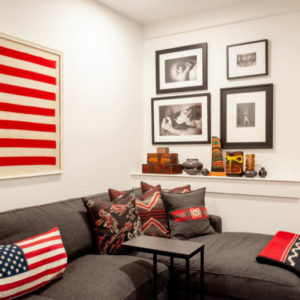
[[138, 232, 300, 300]]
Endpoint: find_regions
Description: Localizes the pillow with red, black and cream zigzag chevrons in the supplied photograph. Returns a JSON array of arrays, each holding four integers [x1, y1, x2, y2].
[[136, 186, 170, 238]]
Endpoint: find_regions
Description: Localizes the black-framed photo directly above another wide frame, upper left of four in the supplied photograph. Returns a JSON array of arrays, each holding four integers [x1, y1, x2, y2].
[[156, 43, 207, 94]]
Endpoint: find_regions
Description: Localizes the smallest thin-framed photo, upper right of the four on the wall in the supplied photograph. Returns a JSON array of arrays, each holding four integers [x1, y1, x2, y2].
[[227, 40, 268, 79]]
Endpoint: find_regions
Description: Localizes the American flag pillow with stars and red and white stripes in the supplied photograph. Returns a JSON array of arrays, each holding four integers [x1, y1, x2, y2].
[[0, 227, 67, 299]]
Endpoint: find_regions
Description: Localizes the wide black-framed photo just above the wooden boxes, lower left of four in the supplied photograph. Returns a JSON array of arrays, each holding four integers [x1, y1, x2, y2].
[[151, 93, 211, 144]]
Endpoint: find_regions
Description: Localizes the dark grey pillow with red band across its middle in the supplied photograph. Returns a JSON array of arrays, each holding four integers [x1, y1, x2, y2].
[[161, 188, 215, 240]]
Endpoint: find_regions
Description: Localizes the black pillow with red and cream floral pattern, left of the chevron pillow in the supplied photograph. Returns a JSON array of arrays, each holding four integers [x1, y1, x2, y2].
[[84, 191, 141, 254]]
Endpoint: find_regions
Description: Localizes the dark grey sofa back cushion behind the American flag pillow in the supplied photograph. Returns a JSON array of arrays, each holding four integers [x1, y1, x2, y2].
[[0, 198, 93, 260]]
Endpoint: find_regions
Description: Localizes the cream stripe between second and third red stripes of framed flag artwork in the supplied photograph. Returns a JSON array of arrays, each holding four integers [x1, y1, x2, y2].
[[0, 74, 58, 93]]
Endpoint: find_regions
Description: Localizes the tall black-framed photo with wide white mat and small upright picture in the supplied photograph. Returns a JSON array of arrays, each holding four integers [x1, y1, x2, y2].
[[221, 84, 273, 149]]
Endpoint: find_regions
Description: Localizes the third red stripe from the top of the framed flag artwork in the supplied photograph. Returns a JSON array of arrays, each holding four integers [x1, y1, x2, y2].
[[0, 83, 56, 101]]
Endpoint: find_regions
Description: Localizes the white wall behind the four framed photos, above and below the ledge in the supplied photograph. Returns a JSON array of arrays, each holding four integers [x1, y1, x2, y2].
[[143, 8, 300, 233]]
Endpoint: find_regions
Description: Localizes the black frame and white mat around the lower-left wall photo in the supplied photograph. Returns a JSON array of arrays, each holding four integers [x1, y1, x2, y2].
[[151, 93, 211, 145]]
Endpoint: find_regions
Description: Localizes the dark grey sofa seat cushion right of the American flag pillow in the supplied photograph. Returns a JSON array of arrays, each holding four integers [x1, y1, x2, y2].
[[33, 255, 168, 300]]
